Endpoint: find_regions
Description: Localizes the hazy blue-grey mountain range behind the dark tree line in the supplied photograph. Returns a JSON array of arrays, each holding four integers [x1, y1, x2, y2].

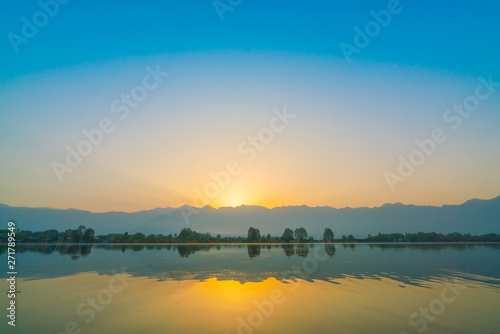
[[0, 196, 500, 238]]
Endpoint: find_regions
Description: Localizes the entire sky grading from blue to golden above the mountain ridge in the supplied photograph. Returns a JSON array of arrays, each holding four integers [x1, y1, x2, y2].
[[0, 0, 500, 212]]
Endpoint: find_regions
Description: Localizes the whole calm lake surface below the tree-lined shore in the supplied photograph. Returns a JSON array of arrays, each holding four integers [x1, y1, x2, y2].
[[0, 244, 500, 334]]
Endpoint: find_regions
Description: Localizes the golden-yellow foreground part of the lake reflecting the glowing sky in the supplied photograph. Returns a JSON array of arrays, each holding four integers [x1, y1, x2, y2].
[[0, 273, 499, 333]]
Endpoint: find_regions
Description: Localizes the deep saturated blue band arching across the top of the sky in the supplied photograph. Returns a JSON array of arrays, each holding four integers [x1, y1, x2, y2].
[[0, 0, 500, 82]]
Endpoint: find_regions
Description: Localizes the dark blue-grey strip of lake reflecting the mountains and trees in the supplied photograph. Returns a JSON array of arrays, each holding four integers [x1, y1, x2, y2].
[[0, 243, 500, 285]]
